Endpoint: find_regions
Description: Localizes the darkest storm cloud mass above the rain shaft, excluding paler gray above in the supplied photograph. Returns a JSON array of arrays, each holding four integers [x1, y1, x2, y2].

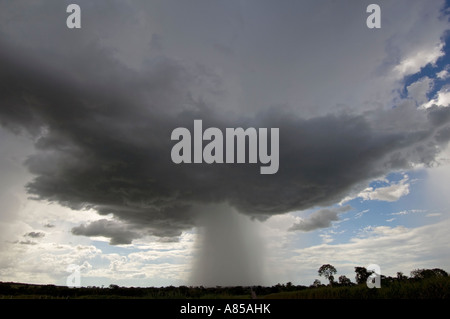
[[0, 1, 450, 244]]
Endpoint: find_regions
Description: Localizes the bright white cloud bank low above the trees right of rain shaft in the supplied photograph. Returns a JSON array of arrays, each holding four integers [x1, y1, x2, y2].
[[278, 220, 450, 285]]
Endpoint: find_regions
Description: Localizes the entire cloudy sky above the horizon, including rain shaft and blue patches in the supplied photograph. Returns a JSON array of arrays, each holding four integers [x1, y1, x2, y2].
[[0, 0, 450, 287]]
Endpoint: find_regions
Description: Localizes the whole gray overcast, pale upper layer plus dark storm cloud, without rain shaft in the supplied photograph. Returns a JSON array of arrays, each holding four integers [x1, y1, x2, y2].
[[0, 1, 450, 248]]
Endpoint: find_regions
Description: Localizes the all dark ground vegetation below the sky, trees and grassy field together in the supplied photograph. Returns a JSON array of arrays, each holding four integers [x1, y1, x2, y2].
[[0, 264, 450, 299]]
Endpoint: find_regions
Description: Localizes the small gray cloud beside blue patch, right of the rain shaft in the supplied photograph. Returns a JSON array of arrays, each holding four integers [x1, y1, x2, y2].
[[289, 206, 351, 232]]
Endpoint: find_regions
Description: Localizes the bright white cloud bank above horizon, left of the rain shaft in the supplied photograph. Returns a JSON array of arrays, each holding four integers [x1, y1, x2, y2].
[[0, 229, 195, 286]]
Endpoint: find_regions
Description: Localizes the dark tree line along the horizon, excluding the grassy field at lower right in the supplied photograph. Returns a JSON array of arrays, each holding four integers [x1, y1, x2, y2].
[[0, 264, 449, 299]]
